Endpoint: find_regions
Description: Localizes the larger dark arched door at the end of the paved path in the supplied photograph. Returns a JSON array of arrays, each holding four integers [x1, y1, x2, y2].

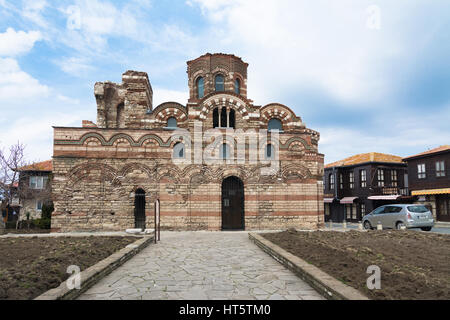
[[222, 176, 245, 230]]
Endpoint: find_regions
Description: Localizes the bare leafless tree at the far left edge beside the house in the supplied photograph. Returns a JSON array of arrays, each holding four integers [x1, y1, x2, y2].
[[0, 142, 26, 227]]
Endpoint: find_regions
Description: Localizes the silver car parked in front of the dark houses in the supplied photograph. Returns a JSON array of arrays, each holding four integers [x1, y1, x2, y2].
[[362, 204, 434, 231]]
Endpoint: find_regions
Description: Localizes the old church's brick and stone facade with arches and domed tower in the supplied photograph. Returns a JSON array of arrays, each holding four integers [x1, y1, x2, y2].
[[52, 54, 323, 231]]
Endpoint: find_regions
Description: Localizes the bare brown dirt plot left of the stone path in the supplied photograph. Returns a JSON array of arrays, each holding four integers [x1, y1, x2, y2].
[[0, 236, 137, 300]]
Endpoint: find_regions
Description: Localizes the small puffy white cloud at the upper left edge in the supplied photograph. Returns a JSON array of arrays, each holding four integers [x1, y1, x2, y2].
[[0, 28, 42, 57]]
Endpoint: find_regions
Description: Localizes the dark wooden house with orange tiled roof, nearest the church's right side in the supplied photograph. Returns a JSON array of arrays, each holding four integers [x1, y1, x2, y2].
[[324, 152, 412, 222]]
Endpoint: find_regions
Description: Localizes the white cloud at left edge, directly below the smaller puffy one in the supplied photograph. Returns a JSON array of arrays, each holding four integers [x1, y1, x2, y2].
[[0, 58, 50, 105]]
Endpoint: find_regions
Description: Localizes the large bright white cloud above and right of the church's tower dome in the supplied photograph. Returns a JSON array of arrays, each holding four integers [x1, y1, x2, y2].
[[190, 0, 422, 108]]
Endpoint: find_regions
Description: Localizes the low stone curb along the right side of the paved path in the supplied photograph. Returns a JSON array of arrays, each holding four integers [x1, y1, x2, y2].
[[248, 233, 369, 300]]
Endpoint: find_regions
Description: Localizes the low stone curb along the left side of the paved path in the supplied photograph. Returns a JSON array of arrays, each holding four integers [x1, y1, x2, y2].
[[34, 233, 155, 300]]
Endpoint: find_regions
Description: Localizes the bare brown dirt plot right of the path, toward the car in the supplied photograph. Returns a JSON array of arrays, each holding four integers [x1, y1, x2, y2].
[[263, 230, 450, 300]]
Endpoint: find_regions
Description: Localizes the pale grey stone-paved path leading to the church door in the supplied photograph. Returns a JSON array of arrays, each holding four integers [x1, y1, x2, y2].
[[80, 232, 323, 300]]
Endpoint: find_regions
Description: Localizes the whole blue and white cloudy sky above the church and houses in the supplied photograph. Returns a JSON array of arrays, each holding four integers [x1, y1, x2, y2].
[[0, 0, 450, 163]]
